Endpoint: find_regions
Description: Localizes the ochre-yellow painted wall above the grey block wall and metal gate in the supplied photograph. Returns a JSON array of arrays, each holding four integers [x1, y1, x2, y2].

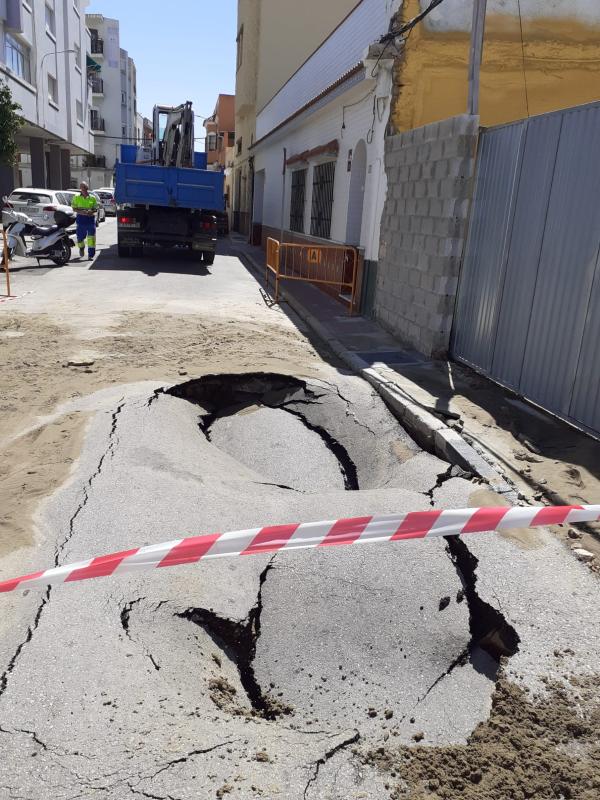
[[392, 0, 600, 131]]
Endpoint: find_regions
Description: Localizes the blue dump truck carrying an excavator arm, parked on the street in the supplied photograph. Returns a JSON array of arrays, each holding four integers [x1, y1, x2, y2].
[[115, 102, 224, 265]]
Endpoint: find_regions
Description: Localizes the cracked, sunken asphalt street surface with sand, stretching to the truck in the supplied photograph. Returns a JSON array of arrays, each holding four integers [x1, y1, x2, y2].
[[0, 223, 600, 800]]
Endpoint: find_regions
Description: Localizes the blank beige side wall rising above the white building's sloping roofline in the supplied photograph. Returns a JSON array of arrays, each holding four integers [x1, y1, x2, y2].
[[254, 0, 358, 111]]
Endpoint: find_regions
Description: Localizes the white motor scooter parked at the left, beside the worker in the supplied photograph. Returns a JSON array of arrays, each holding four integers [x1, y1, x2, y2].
[[2, 198, 76, 267]]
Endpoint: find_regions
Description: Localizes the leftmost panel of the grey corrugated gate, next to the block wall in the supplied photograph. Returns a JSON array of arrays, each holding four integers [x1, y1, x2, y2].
[[453, 123, 523, 372]]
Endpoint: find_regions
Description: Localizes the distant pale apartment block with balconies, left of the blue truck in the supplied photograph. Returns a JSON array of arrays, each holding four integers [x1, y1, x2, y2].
[[73, 14, 137, 188]]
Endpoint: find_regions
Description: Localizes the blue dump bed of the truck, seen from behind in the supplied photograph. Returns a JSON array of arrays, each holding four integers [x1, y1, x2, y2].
[[115, 162, 225, 211]]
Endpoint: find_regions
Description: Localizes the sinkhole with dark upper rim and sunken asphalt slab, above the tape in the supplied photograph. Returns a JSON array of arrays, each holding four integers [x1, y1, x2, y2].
[[167, 373, 359, 492]]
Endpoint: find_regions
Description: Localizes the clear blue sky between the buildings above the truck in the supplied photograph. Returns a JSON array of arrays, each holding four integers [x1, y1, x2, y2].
[[86, 0, 237, 136]]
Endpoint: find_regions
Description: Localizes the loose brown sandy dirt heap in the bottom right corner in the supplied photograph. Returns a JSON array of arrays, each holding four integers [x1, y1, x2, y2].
[[364, 672, 600, 800]]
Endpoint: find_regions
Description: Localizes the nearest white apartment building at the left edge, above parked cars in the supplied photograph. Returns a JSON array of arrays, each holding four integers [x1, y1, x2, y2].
[[0, 0, 93, 194]]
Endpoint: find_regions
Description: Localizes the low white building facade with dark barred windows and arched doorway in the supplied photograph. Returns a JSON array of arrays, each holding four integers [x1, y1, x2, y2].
[[251, 0, 398, 310]]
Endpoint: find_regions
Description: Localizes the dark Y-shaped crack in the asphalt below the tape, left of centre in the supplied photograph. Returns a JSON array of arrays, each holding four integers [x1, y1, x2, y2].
[[175, 556, 292, 720]]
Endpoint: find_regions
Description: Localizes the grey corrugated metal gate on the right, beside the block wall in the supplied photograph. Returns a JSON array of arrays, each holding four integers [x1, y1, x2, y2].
[[452, 103, 600, 434]]
